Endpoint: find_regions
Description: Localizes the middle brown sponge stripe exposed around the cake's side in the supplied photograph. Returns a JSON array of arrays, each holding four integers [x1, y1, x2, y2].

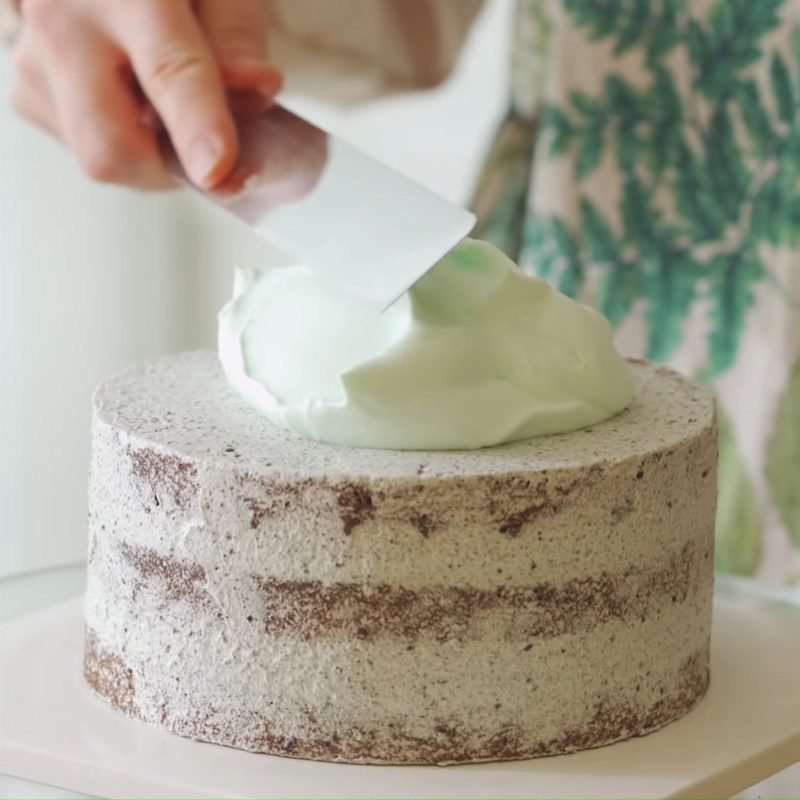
[[108, 541, 711, 641]]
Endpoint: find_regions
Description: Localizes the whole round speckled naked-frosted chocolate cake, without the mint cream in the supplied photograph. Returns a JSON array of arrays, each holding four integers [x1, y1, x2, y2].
[[85, 353, 716, 763]]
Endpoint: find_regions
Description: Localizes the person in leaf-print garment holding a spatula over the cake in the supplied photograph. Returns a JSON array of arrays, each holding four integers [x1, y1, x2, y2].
[[4, 0, 800, 584]]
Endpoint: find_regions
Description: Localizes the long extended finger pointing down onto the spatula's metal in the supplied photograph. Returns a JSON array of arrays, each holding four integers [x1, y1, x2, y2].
[[115, 0, 238, 188]]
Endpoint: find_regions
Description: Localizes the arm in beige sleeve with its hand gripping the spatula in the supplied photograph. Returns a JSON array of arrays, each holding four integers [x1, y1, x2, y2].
[[0, 0, 481, 189]]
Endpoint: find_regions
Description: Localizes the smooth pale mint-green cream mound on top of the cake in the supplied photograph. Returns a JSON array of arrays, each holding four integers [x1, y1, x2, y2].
[[219, 239, 633, 450]]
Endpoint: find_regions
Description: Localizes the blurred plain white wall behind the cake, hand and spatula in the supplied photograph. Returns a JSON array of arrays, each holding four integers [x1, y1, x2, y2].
[[0, 0, 513, 577]]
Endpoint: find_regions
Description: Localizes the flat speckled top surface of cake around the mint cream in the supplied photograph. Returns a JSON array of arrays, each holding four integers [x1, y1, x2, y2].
[[94, 351, 714, 480]]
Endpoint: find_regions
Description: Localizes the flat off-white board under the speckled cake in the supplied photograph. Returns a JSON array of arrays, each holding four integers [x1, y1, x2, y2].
[[0, 580, 800, 798]]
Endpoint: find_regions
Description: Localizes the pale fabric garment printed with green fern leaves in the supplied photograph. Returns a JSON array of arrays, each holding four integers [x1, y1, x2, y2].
[[475, 0, 800, 582]]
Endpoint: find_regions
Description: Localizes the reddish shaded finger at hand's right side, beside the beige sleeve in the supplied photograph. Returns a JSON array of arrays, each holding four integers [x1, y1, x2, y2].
[[196, 0, 283, 100]]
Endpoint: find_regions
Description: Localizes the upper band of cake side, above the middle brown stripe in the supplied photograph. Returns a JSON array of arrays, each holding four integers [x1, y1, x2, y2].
[[90, 416, 716, 590]]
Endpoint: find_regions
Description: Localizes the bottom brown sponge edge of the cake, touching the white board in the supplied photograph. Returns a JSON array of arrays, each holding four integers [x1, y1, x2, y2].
[[84, 630, 709, 765]]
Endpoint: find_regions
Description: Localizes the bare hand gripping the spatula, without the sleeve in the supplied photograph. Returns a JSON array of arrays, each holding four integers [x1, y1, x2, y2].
[[12, 0, 281, 189]]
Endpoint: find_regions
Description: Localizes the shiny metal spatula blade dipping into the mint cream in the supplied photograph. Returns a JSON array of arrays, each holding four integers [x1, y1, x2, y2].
[[166, 105, 475, 309]]
